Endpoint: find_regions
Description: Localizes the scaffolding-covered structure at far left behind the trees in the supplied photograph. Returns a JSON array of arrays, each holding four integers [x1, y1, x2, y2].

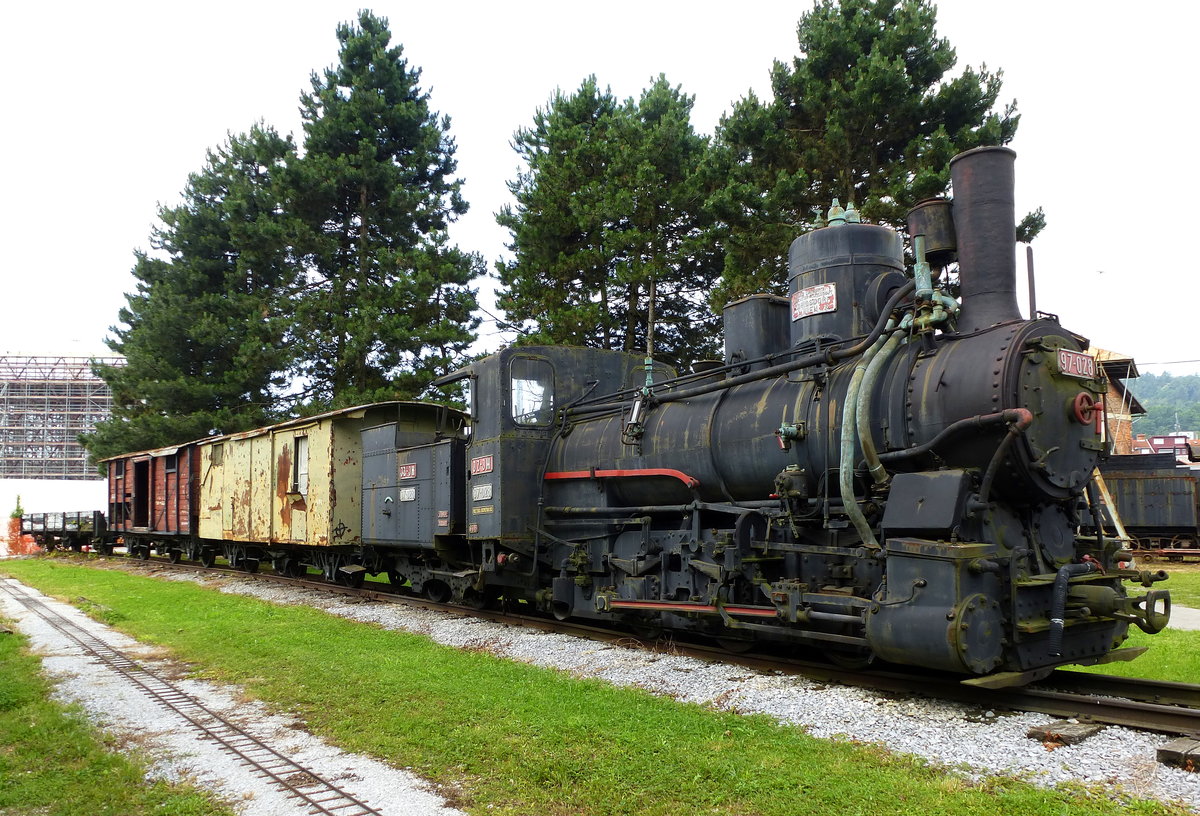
[[0, 356, 125, 479]]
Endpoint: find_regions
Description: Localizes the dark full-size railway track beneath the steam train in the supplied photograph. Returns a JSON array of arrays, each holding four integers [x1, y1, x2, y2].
[[25, 557, 1200, 738]]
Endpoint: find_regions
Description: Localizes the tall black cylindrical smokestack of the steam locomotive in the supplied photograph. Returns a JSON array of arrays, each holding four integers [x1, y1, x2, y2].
[[950, 148, 1021, 332]]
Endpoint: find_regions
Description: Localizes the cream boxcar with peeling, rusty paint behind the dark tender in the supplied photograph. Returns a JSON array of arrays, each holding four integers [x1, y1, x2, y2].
[[198, 402, 445, 547]]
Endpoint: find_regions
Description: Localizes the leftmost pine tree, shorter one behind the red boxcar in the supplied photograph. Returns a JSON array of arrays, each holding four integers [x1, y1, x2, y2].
[[83, 126, 295, 460]]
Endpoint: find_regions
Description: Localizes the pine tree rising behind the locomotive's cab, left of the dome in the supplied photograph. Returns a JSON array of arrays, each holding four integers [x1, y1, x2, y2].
[[497, 77, 719, 365]]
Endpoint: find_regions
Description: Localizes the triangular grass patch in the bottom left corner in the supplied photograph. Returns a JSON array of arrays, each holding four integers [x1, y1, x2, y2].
[[0, 604, 233, 816]]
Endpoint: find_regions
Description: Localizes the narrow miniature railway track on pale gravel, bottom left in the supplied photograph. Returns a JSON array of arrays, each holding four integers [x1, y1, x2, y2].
[[0, 581, 382, 816]]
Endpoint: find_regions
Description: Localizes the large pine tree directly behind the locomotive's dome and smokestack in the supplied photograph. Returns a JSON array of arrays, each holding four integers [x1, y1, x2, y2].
[[709, 0, 1036, 306]]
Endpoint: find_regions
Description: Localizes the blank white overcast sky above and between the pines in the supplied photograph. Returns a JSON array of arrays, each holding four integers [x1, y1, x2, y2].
[[0, 0, 1200, 373]]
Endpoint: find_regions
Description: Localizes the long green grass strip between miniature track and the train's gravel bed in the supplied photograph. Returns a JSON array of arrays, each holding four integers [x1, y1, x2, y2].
[[4, 560, 1182, 816]]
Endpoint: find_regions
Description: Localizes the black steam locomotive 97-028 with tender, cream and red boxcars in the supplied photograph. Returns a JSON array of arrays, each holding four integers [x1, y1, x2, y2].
[[28, 148, 1170, 685]]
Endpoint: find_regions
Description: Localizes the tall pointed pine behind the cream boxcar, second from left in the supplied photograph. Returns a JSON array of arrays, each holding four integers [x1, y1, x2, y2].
[[293, 11, 482, 408]]
